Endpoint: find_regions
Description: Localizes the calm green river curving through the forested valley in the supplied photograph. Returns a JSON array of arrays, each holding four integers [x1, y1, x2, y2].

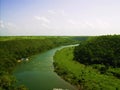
[[14, 45, 76, 90]]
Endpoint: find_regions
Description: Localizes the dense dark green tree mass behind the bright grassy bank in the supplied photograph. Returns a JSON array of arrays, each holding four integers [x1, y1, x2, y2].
[[74, 35, 120, 67]]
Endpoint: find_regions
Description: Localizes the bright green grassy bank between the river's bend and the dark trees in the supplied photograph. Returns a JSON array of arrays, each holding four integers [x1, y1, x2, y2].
[[54, 47, 120, 90]]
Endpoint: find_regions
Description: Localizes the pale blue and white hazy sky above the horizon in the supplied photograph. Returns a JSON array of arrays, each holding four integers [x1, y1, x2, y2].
[[0, 0, 120, 36]]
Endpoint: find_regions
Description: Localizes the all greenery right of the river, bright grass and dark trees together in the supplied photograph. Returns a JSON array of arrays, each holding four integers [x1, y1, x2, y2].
[[54, 35, 120, 90]]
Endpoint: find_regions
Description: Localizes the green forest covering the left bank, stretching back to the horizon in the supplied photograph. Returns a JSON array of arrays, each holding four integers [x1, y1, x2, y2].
[[0, 36, 86, 90]]
